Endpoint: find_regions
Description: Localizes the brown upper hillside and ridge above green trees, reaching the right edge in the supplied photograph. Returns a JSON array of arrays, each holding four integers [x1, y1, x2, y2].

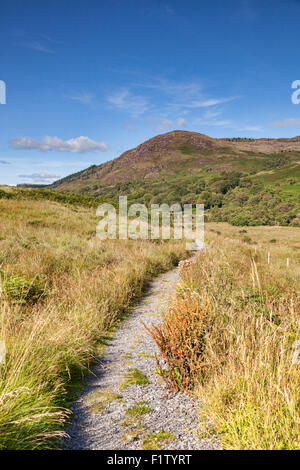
[[51, 131, 300, 195]]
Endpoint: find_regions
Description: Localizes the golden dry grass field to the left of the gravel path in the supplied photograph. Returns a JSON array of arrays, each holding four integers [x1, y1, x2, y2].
[[0, 200, 185, 449]]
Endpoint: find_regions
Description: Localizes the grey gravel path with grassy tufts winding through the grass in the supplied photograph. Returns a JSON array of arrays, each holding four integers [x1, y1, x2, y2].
[[64, 269, 219, 450]]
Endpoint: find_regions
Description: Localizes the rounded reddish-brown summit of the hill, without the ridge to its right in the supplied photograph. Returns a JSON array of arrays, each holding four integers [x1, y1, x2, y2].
[[52, 131, 222, 190]]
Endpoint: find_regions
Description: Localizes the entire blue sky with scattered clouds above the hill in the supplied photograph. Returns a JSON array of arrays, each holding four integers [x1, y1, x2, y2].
[[0, 0, 300, 184]]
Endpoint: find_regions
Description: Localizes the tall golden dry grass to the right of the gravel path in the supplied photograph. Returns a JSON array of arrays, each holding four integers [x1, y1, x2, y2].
[[150, 224, 300, 449]]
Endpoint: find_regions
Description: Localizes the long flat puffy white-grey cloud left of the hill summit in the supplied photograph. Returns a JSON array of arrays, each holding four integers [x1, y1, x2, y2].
[[11, 136, 108, 153]]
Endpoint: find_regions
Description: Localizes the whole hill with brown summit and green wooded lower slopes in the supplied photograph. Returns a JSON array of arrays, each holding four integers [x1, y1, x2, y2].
[[47, 131, 300, 226]]
